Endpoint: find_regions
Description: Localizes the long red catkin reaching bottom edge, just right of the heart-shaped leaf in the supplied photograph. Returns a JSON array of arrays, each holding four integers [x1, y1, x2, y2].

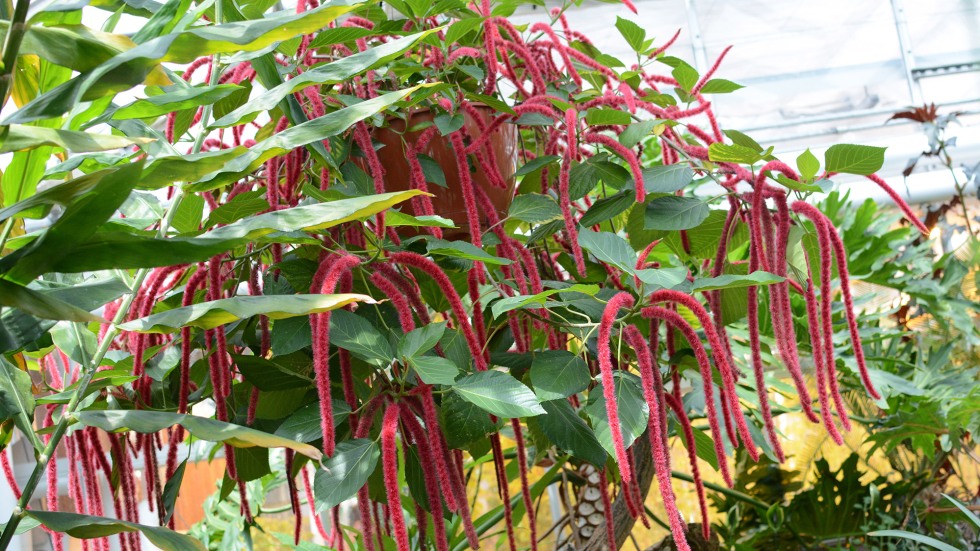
[[623, 328, 690, 550]]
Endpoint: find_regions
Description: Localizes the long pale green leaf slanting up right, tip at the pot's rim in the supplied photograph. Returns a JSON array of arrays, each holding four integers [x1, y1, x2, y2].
[[197, 86, 430, 192]]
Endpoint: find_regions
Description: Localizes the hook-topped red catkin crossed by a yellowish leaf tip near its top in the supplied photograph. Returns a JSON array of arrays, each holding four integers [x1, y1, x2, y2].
[[310, 255, 361, 457]]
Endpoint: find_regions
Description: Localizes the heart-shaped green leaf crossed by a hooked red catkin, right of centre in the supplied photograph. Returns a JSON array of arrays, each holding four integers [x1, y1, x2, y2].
[[585, 371, 650, 456]]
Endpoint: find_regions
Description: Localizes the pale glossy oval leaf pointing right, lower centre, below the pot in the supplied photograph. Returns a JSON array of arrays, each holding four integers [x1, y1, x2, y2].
[[452, 371, 545, 418]]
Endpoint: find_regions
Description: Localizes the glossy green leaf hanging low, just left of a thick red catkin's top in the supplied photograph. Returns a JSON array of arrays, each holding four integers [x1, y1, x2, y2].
[[313, 438, 381, 511]]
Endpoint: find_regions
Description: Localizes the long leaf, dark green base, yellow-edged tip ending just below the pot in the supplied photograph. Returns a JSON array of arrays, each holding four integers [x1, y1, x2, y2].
[[49, 190, 421, 273]]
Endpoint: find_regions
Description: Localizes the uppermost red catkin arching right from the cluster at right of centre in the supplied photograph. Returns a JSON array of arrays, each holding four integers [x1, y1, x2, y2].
[[644, 289, 759, 461]]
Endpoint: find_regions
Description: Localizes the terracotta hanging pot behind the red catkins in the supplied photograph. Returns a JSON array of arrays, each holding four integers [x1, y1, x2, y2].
[[358, 105, 518, 239]]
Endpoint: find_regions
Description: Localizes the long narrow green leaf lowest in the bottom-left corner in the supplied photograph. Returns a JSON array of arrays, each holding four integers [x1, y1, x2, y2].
[[27, 511, 205, 551]]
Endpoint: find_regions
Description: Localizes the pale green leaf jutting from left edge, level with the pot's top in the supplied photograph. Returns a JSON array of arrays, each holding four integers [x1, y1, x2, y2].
[[0, 124, 153, 153]]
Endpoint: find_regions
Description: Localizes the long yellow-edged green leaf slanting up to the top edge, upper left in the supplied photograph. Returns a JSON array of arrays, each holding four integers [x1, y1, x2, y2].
[[4, 0, 359, 124]]
